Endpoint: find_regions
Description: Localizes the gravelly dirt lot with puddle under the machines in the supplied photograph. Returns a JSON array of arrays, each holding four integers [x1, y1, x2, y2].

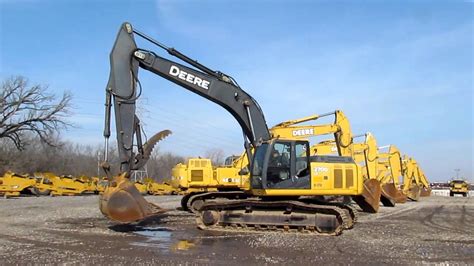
[[0, 196, 474, 265]]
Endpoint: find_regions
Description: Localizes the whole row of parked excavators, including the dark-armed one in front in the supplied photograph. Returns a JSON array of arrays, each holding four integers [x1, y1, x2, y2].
[[100, 23, 436, 235]]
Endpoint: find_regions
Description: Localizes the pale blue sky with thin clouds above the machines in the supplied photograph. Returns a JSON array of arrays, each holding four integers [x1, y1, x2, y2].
[[0, 0, 474, 180]]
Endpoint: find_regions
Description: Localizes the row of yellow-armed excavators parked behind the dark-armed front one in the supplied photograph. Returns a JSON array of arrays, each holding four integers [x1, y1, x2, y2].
[[172, 110, 430, 212]]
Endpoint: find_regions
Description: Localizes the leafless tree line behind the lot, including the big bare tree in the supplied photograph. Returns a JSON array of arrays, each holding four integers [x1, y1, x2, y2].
[[0, 76, 224, 181]]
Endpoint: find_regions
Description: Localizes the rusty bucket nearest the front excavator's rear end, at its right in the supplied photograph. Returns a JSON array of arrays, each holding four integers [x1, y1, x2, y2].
[[353, 179, 382, 213]]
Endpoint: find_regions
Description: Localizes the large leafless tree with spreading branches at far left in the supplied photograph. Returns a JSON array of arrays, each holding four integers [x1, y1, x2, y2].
[[0, 76, 71, 150]]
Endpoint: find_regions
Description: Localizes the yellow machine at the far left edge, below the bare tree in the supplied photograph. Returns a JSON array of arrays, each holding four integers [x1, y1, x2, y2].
[[0, 171, 36, 198]]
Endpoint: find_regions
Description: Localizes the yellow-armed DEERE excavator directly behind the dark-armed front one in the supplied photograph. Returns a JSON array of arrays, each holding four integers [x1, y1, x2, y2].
[[178, 110, 380, 213]]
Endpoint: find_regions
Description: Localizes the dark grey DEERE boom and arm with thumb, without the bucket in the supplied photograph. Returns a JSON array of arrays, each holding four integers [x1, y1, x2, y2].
[[104, 23, 270, 172]]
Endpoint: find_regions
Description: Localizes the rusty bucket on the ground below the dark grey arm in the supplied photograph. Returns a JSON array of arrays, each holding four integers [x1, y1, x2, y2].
[[100, 173, 167, 223]]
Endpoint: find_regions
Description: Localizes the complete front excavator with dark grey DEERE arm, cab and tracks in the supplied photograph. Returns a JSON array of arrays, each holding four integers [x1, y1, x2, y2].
[[100, 23, 363, 235]]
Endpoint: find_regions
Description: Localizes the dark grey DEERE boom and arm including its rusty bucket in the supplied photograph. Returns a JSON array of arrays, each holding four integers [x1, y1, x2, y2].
[[100, 23, 270, 223]]
